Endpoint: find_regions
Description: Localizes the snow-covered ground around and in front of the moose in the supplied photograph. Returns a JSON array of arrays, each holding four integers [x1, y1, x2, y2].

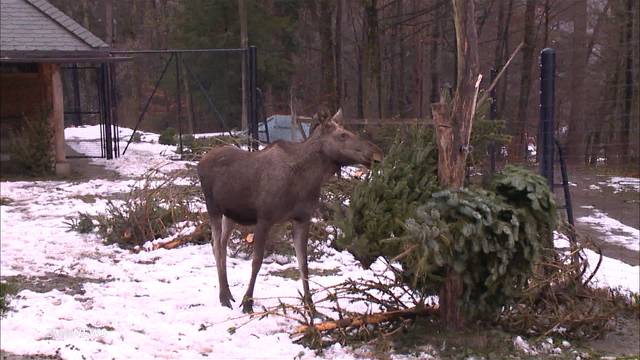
[[0, 128, 640, 359]]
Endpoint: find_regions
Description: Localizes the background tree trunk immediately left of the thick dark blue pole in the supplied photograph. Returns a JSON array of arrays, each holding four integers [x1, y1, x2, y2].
[[511, 0, 536, 160]]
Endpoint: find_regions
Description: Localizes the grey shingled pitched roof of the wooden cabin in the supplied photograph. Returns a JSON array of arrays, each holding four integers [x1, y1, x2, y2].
[[0, 0, 110, 62]]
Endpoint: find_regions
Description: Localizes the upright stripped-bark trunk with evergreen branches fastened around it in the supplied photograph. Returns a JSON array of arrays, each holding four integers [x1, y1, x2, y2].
[[432, 0, 480, 329]]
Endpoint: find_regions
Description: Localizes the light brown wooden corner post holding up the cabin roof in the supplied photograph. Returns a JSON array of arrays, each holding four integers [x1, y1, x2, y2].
[[41, 64, 71, 176]]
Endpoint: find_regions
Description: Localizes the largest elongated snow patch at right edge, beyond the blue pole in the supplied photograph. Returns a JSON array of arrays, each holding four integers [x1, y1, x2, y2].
[[576, 209, 640, 251]]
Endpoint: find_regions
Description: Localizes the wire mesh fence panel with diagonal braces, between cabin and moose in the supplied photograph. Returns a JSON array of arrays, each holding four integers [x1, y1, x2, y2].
[[110, 49, 248, 151]]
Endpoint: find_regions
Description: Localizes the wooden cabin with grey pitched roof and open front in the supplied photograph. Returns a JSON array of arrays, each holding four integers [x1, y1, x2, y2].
[[0, 0, 111, 175]]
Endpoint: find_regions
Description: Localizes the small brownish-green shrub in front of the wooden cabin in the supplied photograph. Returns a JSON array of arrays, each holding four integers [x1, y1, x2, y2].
[[10, 117, 55, 176]]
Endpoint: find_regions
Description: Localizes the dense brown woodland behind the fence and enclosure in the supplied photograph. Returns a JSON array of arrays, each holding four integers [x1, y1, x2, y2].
[[51, 0, 640, 167]]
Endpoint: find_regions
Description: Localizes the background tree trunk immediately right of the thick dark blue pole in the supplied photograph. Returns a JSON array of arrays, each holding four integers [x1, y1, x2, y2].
[[565, 0, 587, 163]]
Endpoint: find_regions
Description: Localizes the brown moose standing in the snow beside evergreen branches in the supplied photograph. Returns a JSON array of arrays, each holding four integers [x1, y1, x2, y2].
[[198, 110, 382, 313]]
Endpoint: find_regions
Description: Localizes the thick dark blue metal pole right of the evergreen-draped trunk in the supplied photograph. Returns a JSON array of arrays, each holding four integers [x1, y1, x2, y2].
[[538, 48, 556, 189]]
